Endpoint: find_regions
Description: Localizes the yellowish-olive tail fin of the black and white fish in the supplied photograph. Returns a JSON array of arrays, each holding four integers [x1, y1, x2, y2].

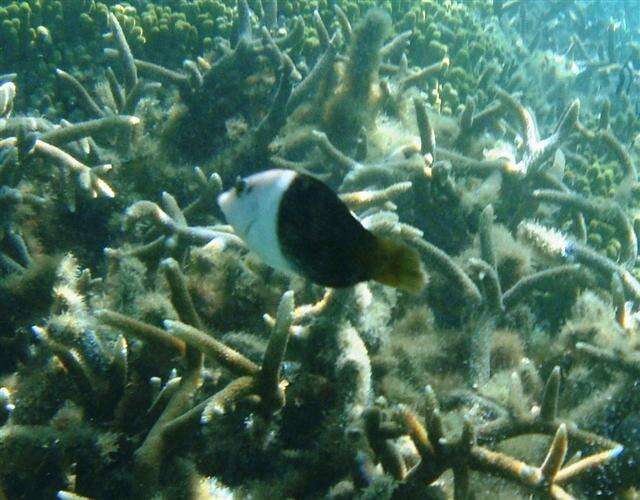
[[367, 237, 426, 294]]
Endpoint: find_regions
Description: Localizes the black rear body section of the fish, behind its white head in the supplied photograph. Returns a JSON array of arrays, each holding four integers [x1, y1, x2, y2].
[[277, 174, 376, 287]]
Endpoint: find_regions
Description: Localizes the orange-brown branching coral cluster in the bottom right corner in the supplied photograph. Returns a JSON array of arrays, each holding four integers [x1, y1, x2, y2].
[[366, 368, 623, 498]]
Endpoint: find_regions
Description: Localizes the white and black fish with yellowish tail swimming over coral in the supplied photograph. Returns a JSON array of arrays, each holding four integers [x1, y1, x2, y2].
[[217, 169, 426, 294]]
